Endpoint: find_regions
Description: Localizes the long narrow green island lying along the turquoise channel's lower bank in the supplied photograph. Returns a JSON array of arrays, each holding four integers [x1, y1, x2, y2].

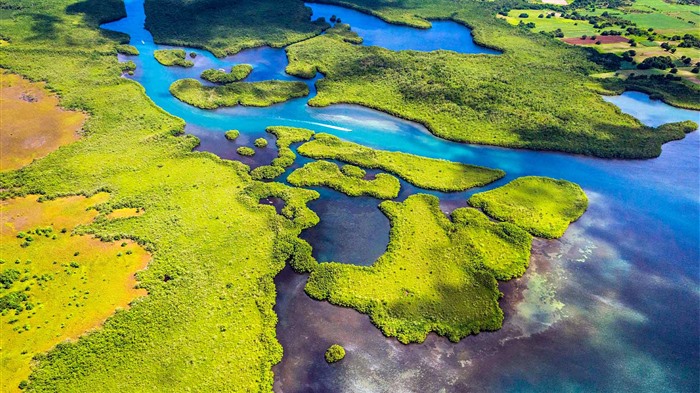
[[297, 134, 505, 192]]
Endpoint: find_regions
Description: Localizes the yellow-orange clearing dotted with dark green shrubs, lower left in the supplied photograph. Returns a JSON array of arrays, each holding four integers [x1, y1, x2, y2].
[[0, 193, 150, 392]]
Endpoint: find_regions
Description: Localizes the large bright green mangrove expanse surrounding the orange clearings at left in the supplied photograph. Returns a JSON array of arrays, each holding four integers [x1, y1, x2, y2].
[[0, 0, 317, 393]]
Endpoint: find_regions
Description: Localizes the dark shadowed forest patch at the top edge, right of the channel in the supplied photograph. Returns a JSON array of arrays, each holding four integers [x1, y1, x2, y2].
[[145, 0, 329, 57]]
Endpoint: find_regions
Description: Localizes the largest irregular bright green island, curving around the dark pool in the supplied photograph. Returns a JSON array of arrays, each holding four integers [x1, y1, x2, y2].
[[306, 194, 531, 343]]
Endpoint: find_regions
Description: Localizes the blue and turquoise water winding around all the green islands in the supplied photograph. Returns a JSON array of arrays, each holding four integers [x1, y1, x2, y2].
[[104, 0, 700, 392]]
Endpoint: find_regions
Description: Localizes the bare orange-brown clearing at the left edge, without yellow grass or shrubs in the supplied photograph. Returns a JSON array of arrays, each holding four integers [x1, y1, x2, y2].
[[0, 74, 85, 171]]
